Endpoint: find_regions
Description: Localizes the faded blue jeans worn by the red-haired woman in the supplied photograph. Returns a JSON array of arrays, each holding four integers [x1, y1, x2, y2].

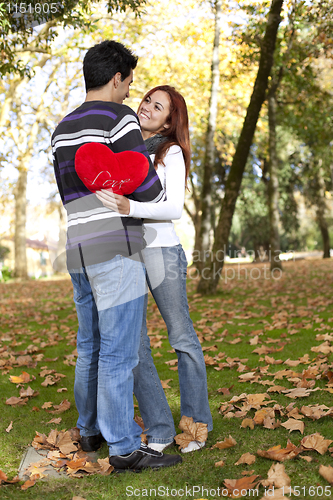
[[134, 245, 213, 443]]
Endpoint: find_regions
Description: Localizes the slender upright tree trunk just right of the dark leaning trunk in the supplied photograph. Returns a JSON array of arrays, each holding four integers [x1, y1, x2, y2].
[[267, 91, 282, 271]]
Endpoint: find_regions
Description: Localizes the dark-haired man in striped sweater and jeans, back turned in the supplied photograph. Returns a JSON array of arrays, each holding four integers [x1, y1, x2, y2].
[[52, 40, 181, 471]]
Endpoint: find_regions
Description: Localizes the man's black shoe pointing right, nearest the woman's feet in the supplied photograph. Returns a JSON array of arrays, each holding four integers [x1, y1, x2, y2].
[[109, 443, 182, 472]]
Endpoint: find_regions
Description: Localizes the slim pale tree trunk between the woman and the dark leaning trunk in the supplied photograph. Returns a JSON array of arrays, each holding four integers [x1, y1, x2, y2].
[[197, 0, 222, 269]]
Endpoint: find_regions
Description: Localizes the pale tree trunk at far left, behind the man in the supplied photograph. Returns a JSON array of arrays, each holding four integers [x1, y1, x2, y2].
[[14, 167, 28, 279]]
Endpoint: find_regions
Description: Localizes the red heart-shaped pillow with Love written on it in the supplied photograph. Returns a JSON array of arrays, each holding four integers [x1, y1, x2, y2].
[[75, 142, 149, 194]]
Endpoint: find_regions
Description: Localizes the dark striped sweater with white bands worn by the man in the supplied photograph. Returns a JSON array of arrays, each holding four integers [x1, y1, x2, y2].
[[52, 101, 163, 269]]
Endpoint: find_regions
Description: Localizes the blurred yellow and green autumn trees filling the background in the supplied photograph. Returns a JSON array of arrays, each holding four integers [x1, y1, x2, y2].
[[0, 0, 333, 293]]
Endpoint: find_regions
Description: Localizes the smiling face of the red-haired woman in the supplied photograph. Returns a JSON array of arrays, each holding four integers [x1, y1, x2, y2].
[[138, 90, 170, 139]]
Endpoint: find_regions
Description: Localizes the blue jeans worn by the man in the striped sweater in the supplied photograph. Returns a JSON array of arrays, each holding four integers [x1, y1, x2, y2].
[[70, 255, 146, 455]]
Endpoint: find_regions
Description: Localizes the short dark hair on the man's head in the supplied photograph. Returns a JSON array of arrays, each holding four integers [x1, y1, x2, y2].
[[83, 40, 138, 92]]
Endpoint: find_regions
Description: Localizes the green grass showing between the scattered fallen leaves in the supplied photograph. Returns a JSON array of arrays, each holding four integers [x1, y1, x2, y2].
[[0, 260, 333, 500]]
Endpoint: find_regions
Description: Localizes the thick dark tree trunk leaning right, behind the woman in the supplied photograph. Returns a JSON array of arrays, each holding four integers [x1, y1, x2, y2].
[[198, 0, 283, 294]]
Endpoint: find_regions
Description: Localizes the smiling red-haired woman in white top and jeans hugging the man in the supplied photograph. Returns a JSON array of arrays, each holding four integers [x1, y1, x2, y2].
[[96, 85, 213, 453]]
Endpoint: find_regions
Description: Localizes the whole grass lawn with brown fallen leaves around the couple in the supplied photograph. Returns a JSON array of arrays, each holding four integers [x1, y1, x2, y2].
[[0, 260, 333, 500]]
